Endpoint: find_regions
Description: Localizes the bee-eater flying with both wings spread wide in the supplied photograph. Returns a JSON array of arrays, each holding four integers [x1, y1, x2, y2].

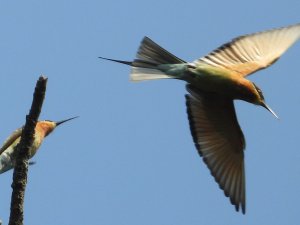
[[100, 24, 300, 214]]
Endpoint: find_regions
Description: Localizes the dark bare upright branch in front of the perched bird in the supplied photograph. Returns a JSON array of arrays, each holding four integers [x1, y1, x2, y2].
[[9, 76, 47, 225]]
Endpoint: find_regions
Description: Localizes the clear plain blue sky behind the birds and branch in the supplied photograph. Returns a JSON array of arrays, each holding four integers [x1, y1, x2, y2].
[[0, 0, 300, 225]]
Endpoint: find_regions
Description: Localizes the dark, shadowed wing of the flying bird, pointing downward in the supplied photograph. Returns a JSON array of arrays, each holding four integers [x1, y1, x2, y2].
[[186, 85, 245, 213]]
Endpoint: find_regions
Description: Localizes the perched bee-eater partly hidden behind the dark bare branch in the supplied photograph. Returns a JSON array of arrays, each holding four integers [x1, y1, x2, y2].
[[0, 117, 77, 174]]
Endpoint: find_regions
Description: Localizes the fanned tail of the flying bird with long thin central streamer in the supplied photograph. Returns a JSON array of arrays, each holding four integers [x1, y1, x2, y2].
[[99, 37, 186, 81]]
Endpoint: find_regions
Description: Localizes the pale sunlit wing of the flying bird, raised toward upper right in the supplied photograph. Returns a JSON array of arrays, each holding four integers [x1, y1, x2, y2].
[[193, 24, 300, 76]]
